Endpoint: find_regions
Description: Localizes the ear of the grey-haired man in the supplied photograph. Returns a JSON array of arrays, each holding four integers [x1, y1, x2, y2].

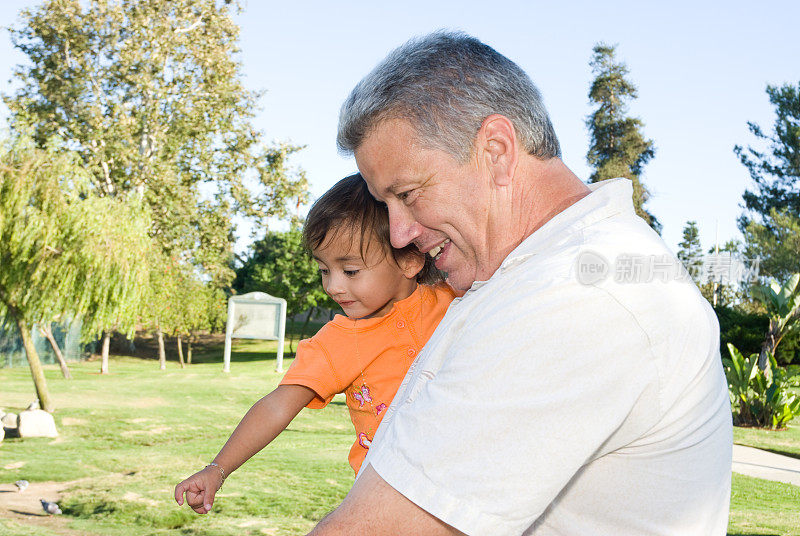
[[477, 114, 519, 186]]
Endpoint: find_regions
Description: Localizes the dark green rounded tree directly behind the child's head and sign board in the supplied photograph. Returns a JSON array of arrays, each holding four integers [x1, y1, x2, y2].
[[233, 224, 336, 352]]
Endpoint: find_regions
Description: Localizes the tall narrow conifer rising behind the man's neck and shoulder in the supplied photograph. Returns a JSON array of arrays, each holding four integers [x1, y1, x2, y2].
[[586, 43, 661, 233]]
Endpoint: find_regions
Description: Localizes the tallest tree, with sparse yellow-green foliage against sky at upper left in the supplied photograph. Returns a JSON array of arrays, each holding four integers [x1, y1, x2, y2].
[[5, 0, 307, 312]]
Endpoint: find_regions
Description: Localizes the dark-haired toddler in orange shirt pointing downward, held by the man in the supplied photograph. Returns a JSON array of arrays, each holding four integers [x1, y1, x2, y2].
[[175, 174, 455, 514]]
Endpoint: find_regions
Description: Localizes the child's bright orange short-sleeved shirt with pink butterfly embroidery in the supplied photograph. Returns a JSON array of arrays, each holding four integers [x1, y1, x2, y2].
[[281, 284, 455, 473]]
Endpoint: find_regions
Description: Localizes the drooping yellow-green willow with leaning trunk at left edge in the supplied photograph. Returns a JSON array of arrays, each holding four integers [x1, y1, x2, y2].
[[0, 138, 150, 411]]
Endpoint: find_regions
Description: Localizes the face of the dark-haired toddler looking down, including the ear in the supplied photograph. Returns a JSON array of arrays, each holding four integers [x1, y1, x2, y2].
[[313, 227, 424, 319]]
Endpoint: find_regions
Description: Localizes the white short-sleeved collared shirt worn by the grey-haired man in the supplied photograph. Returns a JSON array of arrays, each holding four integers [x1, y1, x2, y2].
[[362, 179, 732, 536]]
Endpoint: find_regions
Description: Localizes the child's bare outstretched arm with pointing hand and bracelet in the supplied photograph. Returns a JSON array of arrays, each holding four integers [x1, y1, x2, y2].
[[175, 385, 316, 514]]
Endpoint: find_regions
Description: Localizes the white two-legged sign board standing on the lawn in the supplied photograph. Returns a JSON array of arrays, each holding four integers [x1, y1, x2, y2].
[[222, 292, 286, 372]]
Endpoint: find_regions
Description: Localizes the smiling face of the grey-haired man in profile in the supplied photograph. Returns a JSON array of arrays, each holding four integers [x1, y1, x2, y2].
[[355, 119, 497, 290]]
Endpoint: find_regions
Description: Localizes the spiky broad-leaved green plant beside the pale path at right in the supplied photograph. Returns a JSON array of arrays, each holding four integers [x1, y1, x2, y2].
[[722, 344, 800, 428]]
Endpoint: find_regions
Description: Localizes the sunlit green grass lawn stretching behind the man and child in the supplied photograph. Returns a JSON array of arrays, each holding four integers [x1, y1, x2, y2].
[[0, 341, 800, 536]]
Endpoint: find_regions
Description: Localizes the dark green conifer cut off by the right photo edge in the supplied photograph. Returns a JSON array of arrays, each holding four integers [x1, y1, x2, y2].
[[734, 83, 800, 279]]
